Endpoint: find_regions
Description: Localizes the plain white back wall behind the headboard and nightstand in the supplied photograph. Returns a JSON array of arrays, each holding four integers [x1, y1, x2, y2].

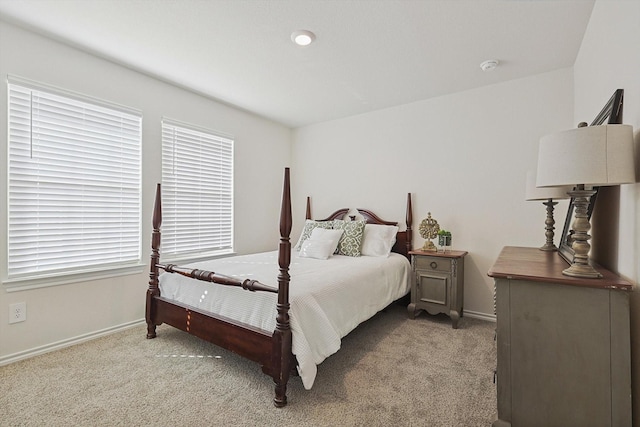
[[292, 69, 573, 316]]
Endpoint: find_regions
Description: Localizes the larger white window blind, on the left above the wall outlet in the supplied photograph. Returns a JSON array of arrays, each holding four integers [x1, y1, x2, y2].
[[8, 80, 142, 278]]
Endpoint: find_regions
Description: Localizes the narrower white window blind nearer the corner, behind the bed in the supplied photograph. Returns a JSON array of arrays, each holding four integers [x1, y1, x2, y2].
[[162, 119, 233, 258]]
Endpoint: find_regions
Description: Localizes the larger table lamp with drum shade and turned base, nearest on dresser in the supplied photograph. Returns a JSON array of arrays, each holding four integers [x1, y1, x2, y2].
[[536, 123, 635, 278]]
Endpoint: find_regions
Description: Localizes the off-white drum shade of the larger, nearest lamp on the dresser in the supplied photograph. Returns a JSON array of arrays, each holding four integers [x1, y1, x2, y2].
[[536, 125, 635, 187]]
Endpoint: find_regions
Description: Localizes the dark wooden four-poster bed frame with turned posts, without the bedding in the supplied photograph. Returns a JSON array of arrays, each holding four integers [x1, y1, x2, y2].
[[145, 168, 413, 407]]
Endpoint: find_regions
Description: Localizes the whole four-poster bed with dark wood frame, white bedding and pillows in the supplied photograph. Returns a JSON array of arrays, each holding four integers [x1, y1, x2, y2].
[[146, 168, 412, 407]]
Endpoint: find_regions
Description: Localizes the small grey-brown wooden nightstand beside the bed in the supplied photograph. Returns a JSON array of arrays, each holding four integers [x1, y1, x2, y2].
[[407, 250, 467, 329]]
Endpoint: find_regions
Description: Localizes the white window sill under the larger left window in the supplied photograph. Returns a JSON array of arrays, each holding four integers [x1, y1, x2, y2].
[[2, 264, 147, 292]]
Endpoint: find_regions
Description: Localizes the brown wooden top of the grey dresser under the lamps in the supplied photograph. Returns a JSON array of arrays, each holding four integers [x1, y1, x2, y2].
[[488, 246, 633, 291]]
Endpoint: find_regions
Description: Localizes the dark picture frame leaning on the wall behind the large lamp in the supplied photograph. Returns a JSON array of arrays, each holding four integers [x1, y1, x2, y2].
[[558, 89, 624, 264]]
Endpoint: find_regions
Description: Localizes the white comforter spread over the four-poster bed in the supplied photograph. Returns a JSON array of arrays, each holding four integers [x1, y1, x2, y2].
[[159, 252, 411, 389]]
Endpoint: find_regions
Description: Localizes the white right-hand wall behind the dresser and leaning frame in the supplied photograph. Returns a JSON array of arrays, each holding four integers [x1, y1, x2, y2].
[[574, 0, 640, 426]]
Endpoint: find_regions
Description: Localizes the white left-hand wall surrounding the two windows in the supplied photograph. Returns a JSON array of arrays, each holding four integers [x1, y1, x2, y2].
[[0, 22, 291, 363]]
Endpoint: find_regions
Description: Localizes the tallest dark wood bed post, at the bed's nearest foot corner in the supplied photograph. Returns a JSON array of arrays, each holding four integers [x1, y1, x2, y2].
[[272, 168, 292, 408]]
